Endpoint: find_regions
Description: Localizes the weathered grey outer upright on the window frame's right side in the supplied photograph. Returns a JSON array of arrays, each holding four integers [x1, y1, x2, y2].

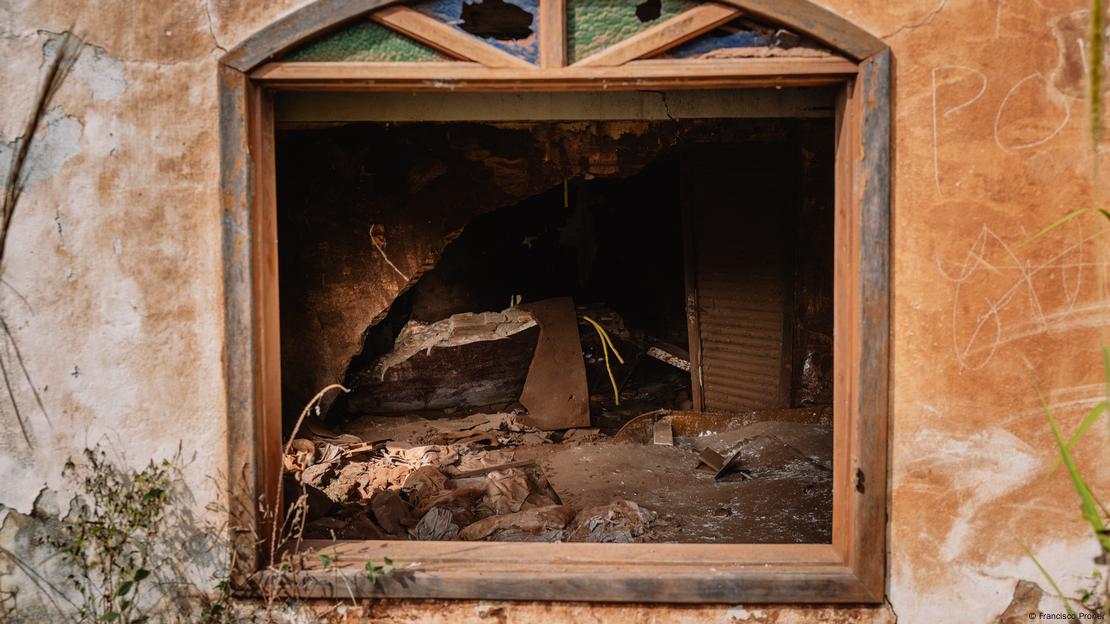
[[849, 49, 891, 602]]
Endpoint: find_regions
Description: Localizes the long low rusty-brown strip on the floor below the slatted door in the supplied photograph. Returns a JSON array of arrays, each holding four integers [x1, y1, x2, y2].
[[613, 406, 833, 444]]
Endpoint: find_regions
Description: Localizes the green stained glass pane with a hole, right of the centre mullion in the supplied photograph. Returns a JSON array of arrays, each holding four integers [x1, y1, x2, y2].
[[566, 0, 698, 63]]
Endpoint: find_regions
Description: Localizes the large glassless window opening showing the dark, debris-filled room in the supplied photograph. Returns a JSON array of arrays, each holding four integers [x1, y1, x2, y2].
[[276, 91, 834, 543]]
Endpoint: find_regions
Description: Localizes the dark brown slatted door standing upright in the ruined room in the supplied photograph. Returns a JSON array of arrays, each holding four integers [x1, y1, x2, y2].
[[683, 145, 798, 412]]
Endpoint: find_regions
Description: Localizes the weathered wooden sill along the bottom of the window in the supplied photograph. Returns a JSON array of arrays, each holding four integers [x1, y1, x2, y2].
[[256, 541, 882, 604]]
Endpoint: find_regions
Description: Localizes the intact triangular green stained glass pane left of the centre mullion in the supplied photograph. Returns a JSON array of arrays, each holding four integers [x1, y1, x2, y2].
[[282, 20, 451, 63]]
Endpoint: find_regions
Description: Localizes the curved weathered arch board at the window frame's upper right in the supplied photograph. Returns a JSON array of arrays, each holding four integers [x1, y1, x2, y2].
[[720, 0, 886, 61]]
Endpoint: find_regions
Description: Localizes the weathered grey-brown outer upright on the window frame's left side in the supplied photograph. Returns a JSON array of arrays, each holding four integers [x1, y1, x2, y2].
[[218, 66, 261, 586]]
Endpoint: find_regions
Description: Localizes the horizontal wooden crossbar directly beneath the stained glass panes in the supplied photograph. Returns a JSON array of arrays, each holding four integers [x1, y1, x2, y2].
[[251, 58, 857, 91]]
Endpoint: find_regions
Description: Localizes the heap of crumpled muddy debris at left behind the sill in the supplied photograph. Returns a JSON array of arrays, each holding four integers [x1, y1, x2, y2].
[[284, 413, 656, 542]]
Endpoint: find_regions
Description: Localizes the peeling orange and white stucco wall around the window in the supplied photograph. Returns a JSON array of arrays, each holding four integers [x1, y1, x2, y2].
[[0, 0, 1110, 623]]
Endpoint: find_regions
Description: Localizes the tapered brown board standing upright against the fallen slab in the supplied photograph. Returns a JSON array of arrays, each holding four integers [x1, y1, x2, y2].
[[518, 296, 589, 431]]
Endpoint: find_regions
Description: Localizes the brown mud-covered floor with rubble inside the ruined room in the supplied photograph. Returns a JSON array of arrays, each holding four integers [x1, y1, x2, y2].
[[285, 411, 833, 543]]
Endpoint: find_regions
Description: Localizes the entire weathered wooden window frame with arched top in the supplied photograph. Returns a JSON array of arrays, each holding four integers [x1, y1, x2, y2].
[[218, 0, 891, 603]]
